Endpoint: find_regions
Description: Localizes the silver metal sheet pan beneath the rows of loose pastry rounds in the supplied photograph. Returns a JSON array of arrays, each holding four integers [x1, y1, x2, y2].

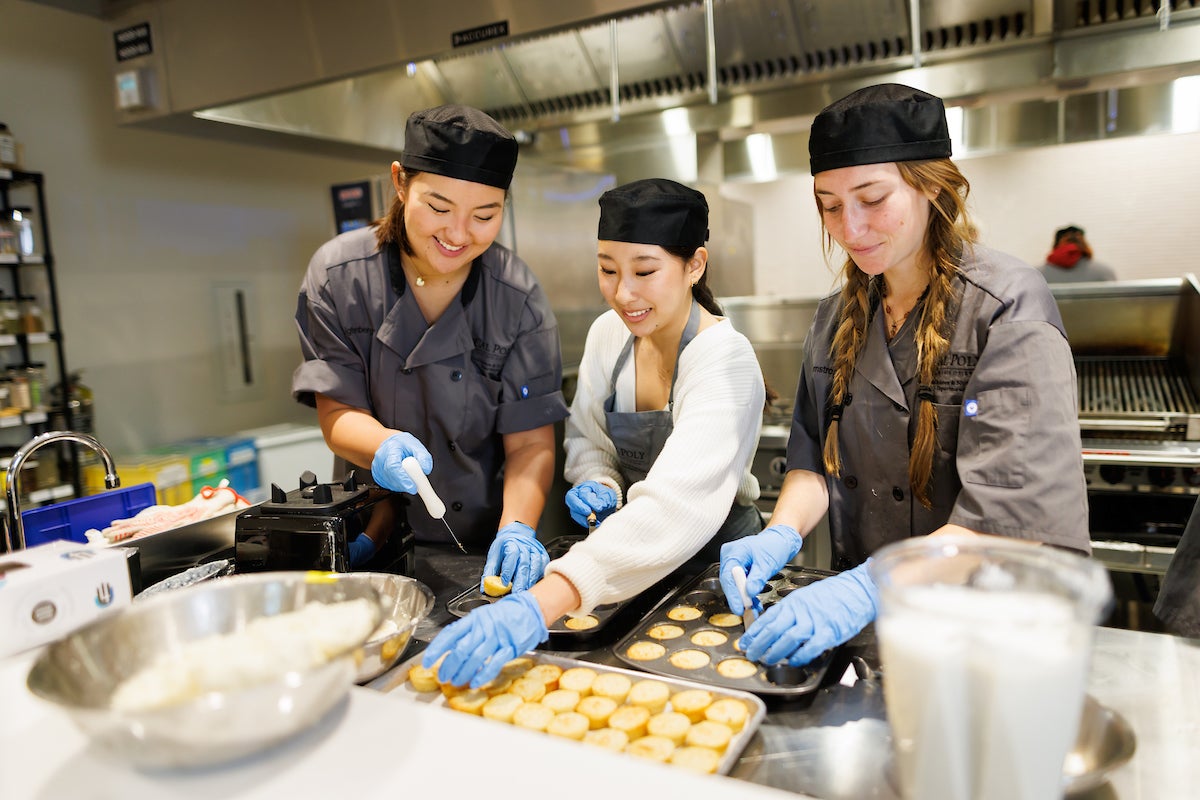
[[379, 650, 767, 775]]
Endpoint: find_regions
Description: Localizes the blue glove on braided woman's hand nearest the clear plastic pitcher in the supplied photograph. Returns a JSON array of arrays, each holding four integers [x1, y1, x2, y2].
[[742, 560, 880, 667]]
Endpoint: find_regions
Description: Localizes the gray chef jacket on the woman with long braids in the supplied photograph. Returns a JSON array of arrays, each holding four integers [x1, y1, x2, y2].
[[787, 246, 1091, 570]]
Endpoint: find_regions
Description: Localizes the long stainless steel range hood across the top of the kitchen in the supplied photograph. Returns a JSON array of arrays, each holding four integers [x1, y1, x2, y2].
[[51, 0, 1200, 180]]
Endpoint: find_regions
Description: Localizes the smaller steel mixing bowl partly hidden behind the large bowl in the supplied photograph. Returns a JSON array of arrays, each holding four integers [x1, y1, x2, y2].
[[348, 572, 433, 684]]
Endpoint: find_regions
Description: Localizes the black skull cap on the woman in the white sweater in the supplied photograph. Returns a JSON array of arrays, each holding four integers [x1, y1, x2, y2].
[[596, 178, 708, 249]]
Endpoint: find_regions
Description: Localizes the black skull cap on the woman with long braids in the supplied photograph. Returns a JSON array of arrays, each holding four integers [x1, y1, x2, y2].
[[809, 83, 950, 175]]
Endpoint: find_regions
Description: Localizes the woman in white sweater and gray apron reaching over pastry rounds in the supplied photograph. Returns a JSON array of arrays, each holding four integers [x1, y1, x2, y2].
[[424, 179, 767, 687]]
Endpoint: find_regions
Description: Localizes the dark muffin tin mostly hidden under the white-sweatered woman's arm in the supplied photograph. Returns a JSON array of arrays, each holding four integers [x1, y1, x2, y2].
[[446, 534, 678, 650]]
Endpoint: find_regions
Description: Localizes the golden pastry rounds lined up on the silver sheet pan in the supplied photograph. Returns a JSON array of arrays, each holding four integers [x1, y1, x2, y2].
[[408, 657, 750, 772]]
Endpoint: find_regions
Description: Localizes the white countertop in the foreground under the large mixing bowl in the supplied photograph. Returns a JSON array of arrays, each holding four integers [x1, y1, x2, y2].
[[0, 654, 798, 800]]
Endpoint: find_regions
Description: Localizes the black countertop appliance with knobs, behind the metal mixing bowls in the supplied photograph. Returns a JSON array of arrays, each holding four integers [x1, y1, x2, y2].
[[234, 470, 415, 576]]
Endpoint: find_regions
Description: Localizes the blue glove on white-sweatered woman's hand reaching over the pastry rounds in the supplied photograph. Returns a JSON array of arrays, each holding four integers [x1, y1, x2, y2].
[[421, 591, 550, 688]]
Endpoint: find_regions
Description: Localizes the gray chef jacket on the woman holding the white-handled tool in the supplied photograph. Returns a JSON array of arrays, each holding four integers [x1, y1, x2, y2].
[[292, 228, 568, 546]]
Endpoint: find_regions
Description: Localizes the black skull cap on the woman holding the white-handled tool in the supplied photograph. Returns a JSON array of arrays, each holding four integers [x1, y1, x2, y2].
[[400, 106, 517, 191]]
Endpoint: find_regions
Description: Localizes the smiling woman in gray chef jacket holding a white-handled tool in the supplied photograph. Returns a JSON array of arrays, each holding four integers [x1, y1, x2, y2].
[[292, 106, 568, 588]]
